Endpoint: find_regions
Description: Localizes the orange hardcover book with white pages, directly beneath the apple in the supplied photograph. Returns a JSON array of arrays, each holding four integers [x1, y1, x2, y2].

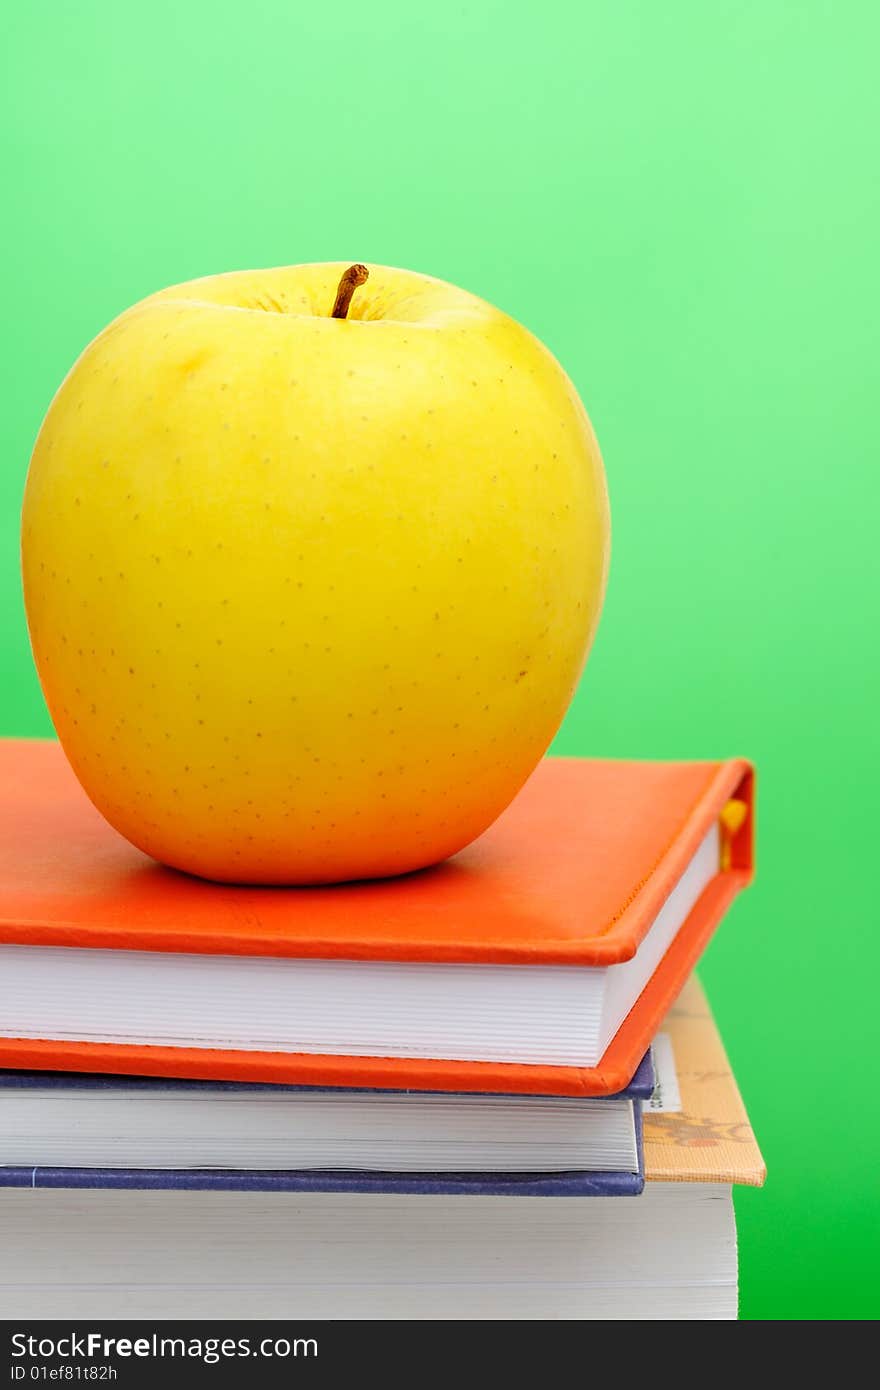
[[0, 741, 753, 1095]]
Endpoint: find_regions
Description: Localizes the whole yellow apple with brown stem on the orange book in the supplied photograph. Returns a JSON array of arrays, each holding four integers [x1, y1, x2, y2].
[[22, 264, 609, 883]]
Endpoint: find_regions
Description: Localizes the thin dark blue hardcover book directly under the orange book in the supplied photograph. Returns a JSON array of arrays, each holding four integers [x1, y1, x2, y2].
[[0, 1055, 653, 1197]]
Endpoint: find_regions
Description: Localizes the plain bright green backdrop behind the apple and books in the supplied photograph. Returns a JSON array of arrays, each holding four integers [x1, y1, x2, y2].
[[0, 0, 880, 1318]]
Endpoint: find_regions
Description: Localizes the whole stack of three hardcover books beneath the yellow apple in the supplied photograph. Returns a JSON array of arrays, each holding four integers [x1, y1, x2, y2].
[[0, 741, 763, 1319]]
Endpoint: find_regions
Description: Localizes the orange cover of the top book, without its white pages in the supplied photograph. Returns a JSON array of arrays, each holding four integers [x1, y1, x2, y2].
[[0, 739, 753, 1095]]
